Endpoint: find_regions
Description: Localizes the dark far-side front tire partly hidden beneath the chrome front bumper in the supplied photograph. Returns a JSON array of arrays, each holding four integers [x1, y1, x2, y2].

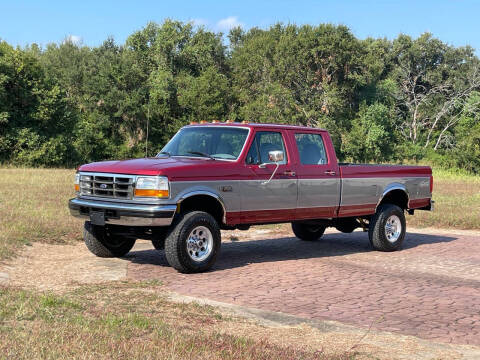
[[83, 221, 135, 257]]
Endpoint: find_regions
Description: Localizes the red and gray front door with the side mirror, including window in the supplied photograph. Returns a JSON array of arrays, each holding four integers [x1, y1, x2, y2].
[[241, 129, 297, 223]]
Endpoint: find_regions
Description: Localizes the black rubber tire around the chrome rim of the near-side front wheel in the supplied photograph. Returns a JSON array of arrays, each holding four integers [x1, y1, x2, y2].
[[165, 211, 221, 273]]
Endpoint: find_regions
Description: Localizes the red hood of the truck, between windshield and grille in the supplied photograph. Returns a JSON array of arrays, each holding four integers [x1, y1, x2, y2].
[[78, 157, 240, 180]]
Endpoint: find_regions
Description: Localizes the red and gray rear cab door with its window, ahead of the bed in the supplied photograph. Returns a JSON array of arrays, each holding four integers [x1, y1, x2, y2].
[[293, 131, 340, 220]]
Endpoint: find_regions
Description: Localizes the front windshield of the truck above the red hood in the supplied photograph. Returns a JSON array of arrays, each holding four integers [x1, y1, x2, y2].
[[157, 126, 248, 160]]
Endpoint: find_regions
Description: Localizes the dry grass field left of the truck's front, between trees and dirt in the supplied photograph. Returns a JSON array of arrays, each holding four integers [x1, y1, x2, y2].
[[0, 168, 81, 259]]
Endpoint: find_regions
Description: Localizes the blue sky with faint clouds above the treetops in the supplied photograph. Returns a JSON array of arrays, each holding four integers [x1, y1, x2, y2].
[[0, 0, 480, 54]]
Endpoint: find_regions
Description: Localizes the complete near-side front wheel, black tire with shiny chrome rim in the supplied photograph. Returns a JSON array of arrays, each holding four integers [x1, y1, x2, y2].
[[165, 211, 221, 273]]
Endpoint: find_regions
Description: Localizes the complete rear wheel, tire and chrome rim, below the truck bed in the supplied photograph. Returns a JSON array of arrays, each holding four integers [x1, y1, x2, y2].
[[368, 204, 406, 251]]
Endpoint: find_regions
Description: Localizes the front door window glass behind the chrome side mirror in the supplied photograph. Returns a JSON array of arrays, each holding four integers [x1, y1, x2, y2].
[[246, 131, 287, 165]]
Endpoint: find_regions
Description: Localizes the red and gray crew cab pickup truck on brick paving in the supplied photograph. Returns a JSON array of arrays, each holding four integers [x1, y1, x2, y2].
[[69, 123, 433, 273]]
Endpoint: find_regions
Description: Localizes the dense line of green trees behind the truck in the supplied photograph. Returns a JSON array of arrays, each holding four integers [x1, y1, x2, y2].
[[0, 20, 480, 172]]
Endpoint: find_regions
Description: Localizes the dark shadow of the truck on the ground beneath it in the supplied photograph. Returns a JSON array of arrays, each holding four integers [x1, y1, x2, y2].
[[126, 232, 457, 271]]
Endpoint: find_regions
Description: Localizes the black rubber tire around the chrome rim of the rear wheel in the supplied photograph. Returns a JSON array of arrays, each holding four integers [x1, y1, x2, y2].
[[368, 204, 406, 251]]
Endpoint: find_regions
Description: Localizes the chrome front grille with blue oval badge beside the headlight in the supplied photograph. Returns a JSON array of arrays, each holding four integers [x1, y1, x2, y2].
[[80, 173, 135, 199]]
